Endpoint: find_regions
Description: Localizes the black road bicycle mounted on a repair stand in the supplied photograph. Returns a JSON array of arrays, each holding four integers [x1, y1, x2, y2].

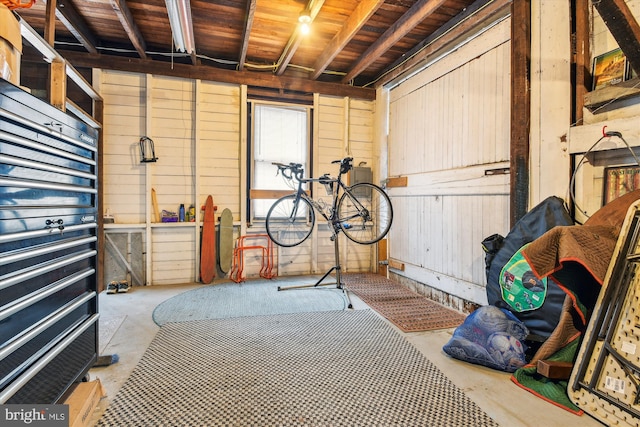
[[266, 157, 393, 247]]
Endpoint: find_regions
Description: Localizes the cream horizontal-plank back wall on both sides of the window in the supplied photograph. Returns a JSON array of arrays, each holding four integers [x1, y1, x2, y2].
[[98, 71, 374, 285]]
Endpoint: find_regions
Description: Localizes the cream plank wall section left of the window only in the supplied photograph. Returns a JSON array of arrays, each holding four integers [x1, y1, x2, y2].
[[100, 71, 240, 284]]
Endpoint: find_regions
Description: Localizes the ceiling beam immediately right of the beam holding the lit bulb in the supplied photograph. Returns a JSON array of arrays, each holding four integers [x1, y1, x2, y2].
[[311, 0, 384, 80]]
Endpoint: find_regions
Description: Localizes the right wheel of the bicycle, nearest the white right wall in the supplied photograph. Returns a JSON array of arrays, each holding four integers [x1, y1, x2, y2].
[[338, 182, 393, 245]]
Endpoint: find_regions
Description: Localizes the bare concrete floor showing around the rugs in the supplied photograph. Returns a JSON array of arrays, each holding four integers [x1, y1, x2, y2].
[[89, 279, 602, 427]]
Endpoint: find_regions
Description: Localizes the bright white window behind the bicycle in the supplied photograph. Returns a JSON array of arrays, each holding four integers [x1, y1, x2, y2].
[[251, 103, 310, 218]]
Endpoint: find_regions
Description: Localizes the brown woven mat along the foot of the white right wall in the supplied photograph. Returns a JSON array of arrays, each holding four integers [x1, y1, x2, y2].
[[342, 273, 465, 332]]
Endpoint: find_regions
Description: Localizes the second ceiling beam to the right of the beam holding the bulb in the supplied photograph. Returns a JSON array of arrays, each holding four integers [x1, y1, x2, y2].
[[342, 0, 445, 83]]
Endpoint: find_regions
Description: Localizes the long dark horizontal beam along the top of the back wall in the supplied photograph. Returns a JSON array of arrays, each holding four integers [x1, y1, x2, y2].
[[59, 50, 376, 100]]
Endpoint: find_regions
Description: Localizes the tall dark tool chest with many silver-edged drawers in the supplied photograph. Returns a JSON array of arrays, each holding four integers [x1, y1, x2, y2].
[[0, 79, 98, 404]]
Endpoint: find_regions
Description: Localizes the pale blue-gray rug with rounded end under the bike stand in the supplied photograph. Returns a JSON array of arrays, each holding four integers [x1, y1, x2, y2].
[[153, 277, 347, 326]]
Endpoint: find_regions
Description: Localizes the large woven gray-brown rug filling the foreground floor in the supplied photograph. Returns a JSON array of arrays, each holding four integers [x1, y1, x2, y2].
[[98, 310, 497, 427]]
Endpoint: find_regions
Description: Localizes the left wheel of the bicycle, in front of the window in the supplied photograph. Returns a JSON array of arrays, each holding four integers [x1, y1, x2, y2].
[[265, 194, 316, 247]]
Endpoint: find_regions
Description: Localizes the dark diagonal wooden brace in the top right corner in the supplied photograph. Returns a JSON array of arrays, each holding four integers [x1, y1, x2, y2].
[[592, 0, 640, 74]]
